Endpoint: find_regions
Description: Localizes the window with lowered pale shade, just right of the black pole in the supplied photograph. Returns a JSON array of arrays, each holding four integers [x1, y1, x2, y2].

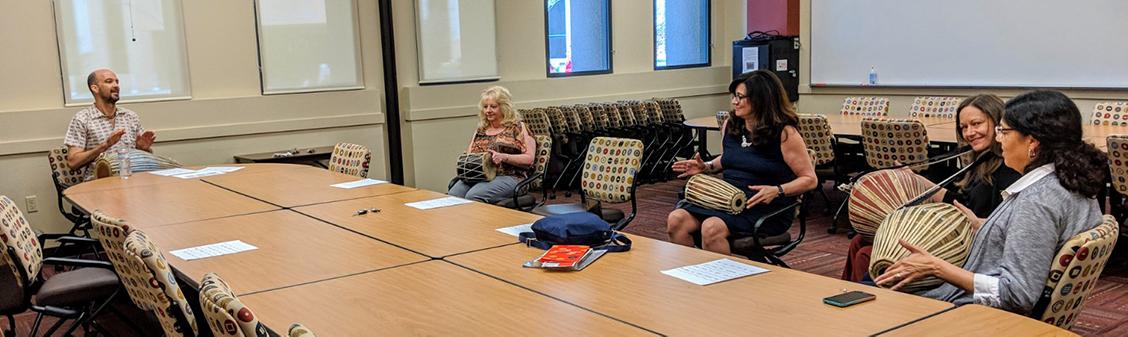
[[415, 0, 497, 85]]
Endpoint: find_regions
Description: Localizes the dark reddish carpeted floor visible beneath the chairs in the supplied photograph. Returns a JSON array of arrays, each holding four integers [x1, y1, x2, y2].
[[5, 180, 1128, 336]]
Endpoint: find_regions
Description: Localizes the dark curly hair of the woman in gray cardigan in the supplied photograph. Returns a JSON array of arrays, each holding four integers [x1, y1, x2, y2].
[[1003, 90, 1109, 197]]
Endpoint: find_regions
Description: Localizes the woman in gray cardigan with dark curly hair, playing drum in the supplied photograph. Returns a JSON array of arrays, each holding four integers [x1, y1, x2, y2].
[[874, 90, 1108, 316]]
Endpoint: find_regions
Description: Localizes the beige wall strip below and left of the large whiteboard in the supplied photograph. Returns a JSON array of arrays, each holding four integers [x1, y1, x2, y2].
[[799, 0, 1128, 121]]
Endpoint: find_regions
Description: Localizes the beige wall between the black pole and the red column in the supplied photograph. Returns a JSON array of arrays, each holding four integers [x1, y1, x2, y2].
[[395, 0, 744, 190]]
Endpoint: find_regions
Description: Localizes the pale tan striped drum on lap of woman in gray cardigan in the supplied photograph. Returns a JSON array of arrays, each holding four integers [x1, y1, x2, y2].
[[870, 203, 973, 293]]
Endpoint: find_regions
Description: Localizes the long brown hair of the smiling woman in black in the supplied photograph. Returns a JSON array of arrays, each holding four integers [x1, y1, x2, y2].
[[955, 94, 1003, 188]]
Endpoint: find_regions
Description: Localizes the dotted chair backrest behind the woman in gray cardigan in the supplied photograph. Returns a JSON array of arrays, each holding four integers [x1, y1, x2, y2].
[[1031, 214, 1119, 329]]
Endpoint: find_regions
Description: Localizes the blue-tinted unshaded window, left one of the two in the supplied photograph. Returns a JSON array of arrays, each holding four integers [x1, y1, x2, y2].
[[545, 0, 611, 77]]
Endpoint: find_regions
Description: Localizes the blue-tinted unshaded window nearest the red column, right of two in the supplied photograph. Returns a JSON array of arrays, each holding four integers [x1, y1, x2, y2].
[[654, 0, 710, 69]]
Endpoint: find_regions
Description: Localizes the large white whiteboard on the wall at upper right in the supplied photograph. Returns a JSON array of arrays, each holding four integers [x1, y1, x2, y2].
[[809, 0, 1128, 88]]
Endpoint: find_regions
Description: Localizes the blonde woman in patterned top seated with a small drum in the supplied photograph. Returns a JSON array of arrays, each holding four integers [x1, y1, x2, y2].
[[447, 86, 537, 204]]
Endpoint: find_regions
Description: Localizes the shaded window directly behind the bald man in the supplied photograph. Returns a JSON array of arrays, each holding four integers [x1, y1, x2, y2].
[[55, 0, 192, 105]]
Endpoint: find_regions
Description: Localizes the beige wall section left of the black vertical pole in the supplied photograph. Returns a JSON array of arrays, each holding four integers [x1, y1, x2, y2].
[[0, 0, 387, 235]]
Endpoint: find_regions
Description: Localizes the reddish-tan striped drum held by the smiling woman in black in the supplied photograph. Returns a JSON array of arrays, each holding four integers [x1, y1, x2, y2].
[[848, 169, 928, 238]]
